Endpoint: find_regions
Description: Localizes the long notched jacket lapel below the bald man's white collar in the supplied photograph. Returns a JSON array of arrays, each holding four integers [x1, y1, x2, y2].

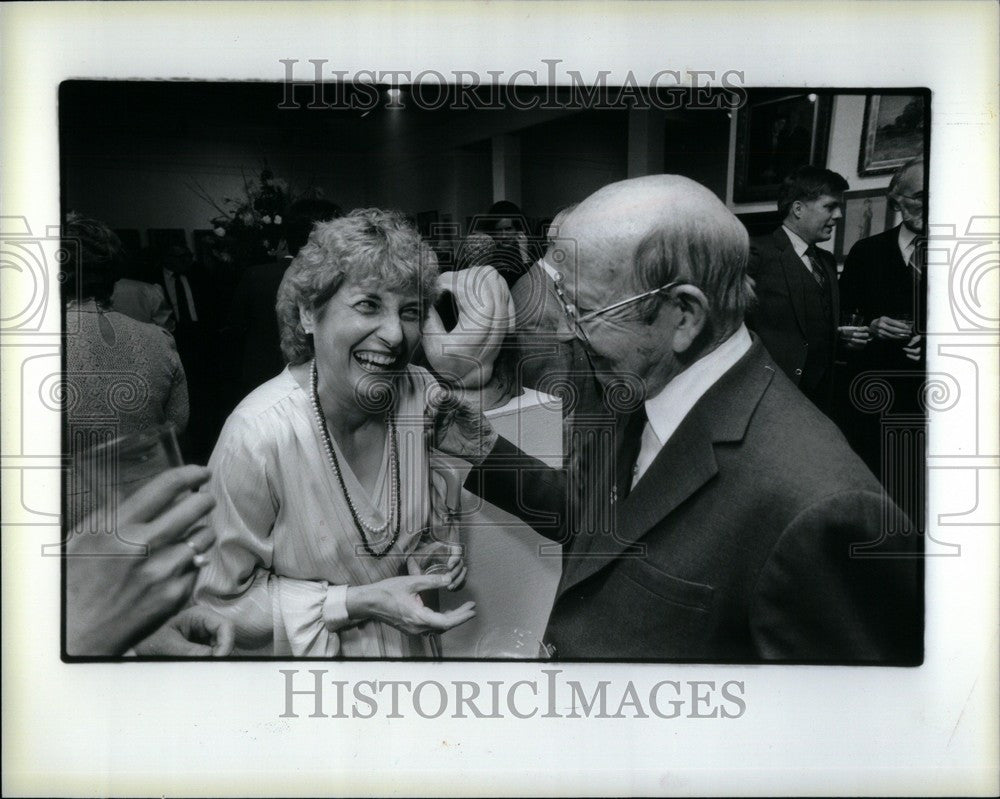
[[558, 336, 775, 595]]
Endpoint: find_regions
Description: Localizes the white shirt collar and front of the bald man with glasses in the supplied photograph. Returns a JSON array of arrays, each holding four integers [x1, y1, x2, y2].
[[632, 325, 753, 487]]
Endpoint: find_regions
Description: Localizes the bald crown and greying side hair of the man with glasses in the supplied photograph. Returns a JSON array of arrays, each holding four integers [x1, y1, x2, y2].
[[559, 175, 752, 334]]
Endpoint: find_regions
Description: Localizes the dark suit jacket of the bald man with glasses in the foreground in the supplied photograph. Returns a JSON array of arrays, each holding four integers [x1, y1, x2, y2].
[[466, 339, 923, 664]]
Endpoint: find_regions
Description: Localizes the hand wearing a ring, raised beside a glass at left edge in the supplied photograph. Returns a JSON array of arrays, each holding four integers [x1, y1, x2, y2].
[[66, 466, 215, 656]]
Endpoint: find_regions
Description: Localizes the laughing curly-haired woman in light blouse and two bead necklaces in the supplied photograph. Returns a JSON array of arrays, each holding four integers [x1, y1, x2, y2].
[[196, 209, 485, 657]]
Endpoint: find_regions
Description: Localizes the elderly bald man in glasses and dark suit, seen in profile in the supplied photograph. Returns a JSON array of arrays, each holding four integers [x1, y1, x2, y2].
[[466, 175, 923, 664]]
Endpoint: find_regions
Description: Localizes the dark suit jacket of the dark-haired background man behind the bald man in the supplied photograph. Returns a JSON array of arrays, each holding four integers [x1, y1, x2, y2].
[[747, 227, 840, 408]]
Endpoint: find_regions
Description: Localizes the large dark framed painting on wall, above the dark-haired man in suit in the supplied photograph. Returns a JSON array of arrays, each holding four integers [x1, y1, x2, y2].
[[733, 89, 833, 203]]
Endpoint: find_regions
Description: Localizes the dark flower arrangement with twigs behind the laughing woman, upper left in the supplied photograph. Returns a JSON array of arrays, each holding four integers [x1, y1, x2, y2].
[[189, 163, 292, 266]]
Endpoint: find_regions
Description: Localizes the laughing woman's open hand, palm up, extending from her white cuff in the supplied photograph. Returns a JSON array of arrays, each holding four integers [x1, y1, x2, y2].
[[347, 574, 476, 635]]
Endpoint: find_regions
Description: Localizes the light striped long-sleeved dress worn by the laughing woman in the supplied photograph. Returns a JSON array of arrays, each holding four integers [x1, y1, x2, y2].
[[195, 366, 446, 657]]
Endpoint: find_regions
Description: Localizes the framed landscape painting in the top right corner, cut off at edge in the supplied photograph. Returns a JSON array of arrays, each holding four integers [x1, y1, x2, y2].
[[858, 94, 927, 175]]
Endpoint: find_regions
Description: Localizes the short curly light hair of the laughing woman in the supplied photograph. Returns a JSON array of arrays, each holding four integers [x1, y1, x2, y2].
[[275, 208, 438, 365]]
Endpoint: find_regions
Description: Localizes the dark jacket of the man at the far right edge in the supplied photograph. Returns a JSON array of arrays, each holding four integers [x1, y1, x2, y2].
[[840, 225, 927, 371]]
